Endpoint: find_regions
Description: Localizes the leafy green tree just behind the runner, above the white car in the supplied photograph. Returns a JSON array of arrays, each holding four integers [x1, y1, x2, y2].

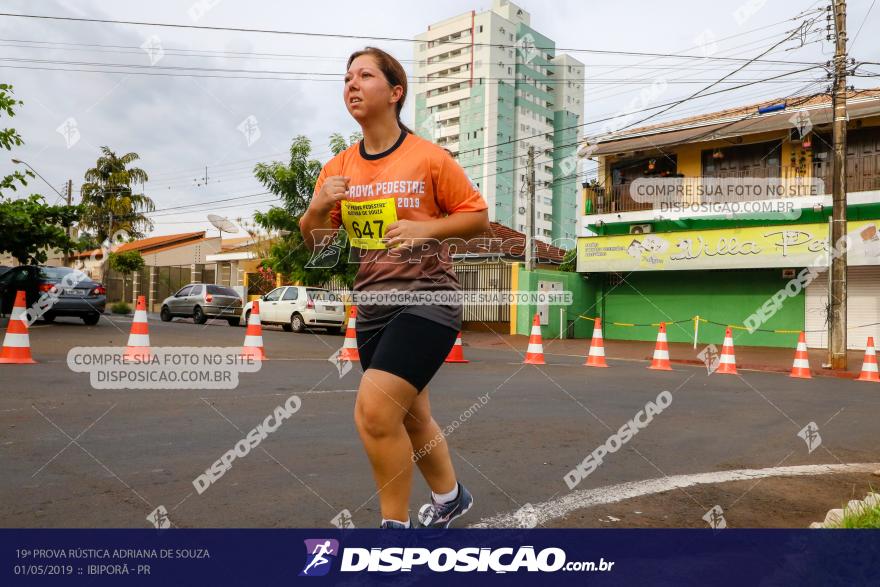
[[254, 133, 360, 287]]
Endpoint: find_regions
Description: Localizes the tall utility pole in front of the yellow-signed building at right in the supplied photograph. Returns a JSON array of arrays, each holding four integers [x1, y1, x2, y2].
[[828, 0, 847, 370]]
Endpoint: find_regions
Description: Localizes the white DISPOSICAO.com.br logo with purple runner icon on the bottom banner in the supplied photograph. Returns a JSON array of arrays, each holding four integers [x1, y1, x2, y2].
[[300, 539, 614, 577]]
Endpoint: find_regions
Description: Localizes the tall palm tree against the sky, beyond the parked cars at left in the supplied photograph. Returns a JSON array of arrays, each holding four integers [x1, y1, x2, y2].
[[81, 147, 155, 242]]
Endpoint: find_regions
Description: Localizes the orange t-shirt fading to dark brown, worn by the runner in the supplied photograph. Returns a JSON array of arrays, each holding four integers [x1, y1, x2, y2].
[[315, 132, 487, 328]]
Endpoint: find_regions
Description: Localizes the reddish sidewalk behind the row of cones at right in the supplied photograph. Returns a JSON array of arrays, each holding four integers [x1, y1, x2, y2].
[[462, 330, 865, 379]]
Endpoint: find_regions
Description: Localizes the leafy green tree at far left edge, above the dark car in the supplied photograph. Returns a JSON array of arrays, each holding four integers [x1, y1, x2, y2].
[[0, 84, 80, 264]]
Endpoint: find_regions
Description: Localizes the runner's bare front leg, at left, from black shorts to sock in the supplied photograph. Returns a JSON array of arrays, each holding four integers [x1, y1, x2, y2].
[[354, 369, 416, 522]]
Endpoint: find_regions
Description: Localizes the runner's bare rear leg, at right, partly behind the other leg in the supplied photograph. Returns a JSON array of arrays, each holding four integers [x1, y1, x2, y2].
[[403, 387, 456, 493]]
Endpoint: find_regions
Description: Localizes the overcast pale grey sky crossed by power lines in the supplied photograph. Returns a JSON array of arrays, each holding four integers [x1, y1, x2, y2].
[[0, 0, 880, 235]]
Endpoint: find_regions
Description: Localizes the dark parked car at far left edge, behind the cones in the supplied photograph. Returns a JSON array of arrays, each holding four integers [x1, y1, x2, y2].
[[0, 265, 107, 326]]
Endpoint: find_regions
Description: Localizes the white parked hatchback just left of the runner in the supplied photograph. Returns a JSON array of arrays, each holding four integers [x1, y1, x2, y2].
[[242, 285, 347, 334]]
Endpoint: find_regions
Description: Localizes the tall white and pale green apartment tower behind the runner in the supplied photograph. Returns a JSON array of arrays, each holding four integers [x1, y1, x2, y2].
[[412, 0, 584, 243]]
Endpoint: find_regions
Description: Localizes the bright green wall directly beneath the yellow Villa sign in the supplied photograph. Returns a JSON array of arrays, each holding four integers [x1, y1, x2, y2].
[[593, 269, 805, 350]]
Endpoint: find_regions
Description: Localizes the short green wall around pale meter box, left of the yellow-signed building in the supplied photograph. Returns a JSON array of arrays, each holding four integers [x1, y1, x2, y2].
[[516, 268, 600, 338]]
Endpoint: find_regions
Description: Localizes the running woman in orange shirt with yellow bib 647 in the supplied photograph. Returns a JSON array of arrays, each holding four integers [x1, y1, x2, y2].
[[300, 47, 489, 528]]
